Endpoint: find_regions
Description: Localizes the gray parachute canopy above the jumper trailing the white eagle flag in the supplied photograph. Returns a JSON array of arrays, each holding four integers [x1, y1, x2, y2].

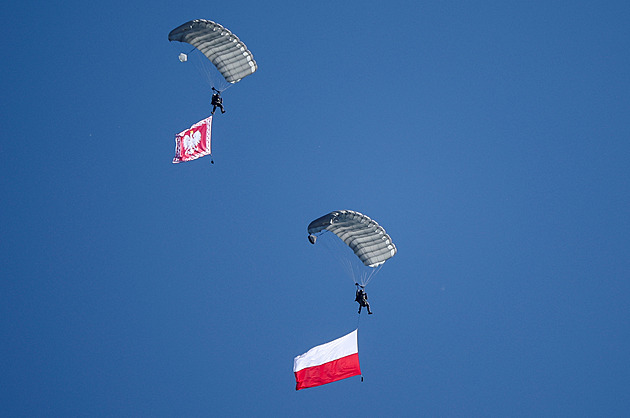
[[168, 19, 258, 83]]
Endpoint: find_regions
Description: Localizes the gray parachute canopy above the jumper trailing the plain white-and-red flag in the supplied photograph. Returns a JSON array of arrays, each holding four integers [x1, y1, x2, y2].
[[308, 210, 396, 267]]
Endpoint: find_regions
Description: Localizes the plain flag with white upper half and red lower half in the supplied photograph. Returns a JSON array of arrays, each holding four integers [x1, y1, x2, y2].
[[293, 329, 361, 390]]
